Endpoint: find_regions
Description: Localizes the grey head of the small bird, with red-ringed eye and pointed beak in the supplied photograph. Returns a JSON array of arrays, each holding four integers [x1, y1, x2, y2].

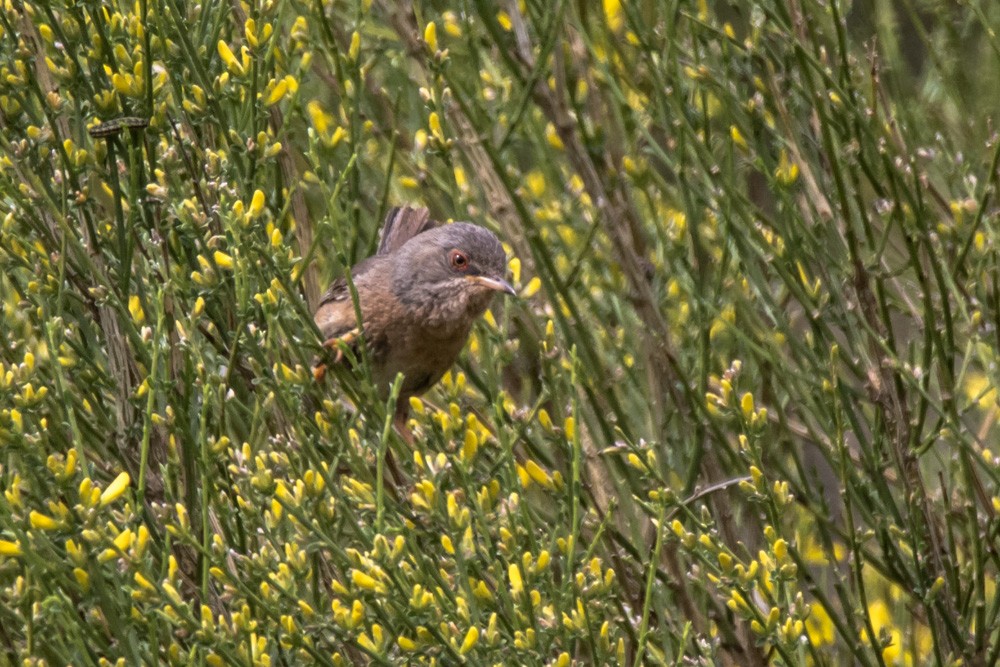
[[392, 222, 515, 323]]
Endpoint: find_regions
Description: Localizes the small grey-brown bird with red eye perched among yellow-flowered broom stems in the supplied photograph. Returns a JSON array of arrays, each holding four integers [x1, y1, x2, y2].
[[313, 207, 515, 428]]
